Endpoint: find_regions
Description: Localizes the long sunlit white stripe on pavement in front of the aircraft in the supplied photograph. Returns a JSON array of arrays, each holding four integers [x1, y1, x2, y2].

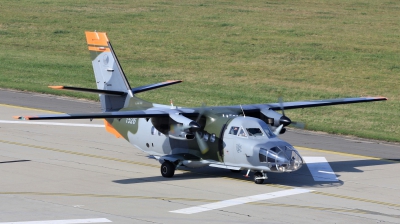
[[170, 188, 313, 214]]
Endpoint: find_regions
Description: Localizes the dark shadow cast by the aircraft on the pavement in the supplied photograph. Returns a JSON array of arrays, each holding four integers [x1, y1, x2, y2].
[[113, 159, 397, 188]]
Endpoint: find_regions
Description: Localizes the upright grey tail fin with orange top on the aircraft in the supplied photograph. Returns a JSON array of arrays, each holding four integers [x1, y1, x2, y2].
[[85, 31, 133, 111]]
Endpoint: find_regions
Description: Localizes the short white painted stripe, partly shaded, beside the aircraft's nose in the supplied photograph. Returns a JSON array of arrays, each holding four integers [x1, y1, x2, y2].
[[303, 157, 339, 182]]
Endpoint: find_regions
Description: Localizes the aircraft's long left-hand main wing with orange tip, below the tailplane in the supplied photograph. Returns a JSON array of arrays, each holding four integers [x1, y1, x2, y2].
[[14, 108, 198, 120]]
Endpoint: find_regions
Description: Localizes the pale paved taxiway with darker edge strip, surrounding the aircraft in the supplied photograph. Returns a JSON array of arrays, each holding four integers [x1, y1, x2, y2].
[[0, 90, 400, 223]]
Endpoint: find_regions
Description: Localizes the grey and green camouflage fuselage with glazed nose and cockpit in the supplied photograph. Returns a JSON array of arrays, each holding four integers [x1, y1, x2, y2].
[[107, 104, 303, 172]]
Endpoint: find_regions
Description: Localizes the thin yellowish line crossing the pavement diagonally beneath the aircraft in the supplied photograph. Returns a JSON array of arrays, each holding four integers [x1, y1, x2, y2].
[[0, 139, 400, 208]]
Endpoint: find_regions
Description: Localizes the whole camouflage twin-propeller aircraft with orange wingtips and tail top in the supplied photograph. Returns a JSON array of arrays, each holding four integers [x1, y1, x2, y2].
[[15, 32, 386, 184]]
